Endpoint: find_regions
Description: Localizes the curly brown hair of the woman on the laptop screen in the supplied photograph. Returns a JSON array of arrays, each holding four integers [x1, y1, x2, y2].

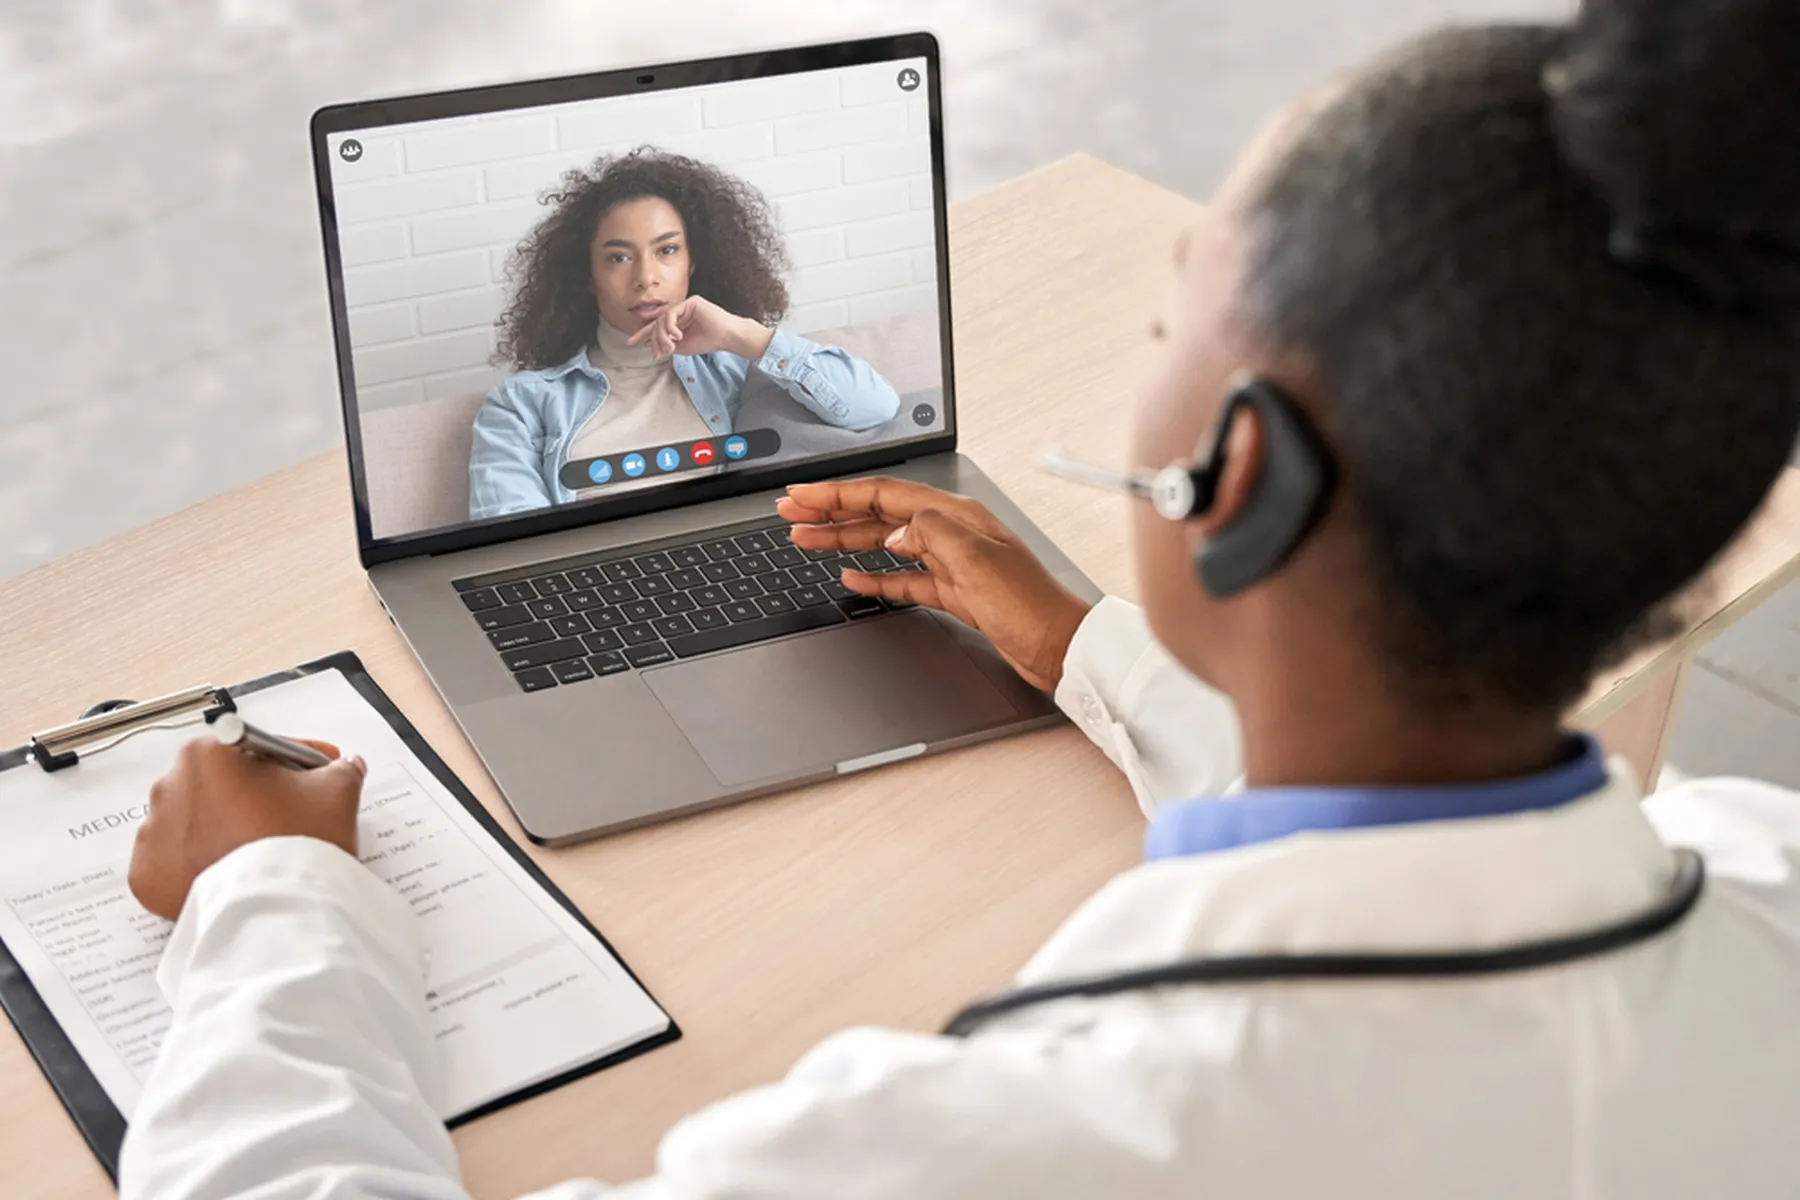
[[495, 146, 788, 371]]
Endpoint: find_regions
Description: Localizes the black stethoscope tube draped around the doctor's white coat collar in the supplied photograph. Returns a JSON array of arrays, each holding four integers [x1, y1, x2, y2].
[[943, 849, 1706, 1038]]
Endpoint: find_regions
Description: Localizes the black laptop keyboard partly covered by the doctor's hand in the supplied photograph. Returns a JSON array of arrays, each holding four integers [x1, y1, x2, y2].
[[455, 524, 923, 691]]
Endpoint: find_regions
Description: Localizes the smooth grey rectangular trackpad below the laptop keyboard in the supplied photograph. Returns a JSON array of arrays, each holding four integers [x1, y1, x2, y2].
[[644, 612, 1017, 788]]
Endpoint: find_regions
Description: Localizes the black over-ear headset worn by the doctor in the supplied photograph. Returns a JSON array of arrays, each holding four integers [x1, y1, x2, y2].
[[1150, 374, 1337, 599]]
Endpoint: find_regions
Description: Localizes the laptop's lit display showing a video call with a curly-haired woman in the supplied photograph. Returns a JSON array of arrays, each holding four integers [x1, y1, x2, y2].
[[328, 59, 945, 538]]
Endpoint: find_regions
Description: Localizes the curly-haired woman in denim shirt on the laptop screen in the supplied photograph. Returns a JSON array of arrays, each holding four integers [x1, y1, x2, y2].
[[468, 146, 900, 520]]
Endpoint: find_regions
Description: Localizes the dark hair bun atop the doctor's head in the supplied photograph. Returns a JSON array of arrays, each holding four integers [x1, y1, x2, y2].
[[1544, 0, 1800, 243]]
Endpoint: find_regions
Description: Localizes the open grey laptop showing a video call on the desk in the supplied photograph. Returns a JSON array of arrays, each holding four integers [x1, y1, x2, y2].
[[311, 34, 1098, 844]]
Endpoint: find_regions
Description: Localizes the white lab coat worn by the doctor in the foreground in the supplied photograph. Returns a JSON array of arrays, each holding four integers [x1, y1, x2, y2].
[[121, 601, 1800, 1200]]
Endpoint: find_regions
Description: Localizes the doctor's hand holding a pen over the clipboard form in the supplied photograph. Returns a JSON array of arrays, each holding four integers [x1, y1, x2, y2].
[[130, 738, 367, 921]]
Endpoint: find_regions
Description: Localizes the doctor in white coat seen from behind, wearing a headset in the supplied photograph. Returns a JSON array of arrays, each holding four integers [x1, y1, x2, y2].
[[121, 0, 1800, 1200]]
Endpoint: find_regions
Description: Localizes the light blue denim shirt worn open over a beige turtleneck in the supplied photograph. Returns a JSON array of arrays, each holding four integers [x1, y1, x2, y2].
[[468, 331, 900, 520]]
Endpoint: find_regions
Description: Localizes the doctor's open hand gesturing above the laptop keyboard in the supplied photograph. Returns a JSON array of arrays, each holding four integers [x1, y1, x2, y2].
[[776, 479, 1089, 689]]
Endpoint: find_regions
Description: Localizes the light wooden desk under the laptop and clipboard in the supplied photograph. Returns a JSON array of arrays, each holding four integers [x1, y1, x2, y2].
[[0, 158, 1800, 1198]]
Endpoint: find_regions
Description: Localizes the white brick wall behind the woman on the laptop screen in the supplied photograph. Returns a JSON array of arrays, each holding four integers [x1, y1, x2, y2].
[[331, 59, 936, 408]]
